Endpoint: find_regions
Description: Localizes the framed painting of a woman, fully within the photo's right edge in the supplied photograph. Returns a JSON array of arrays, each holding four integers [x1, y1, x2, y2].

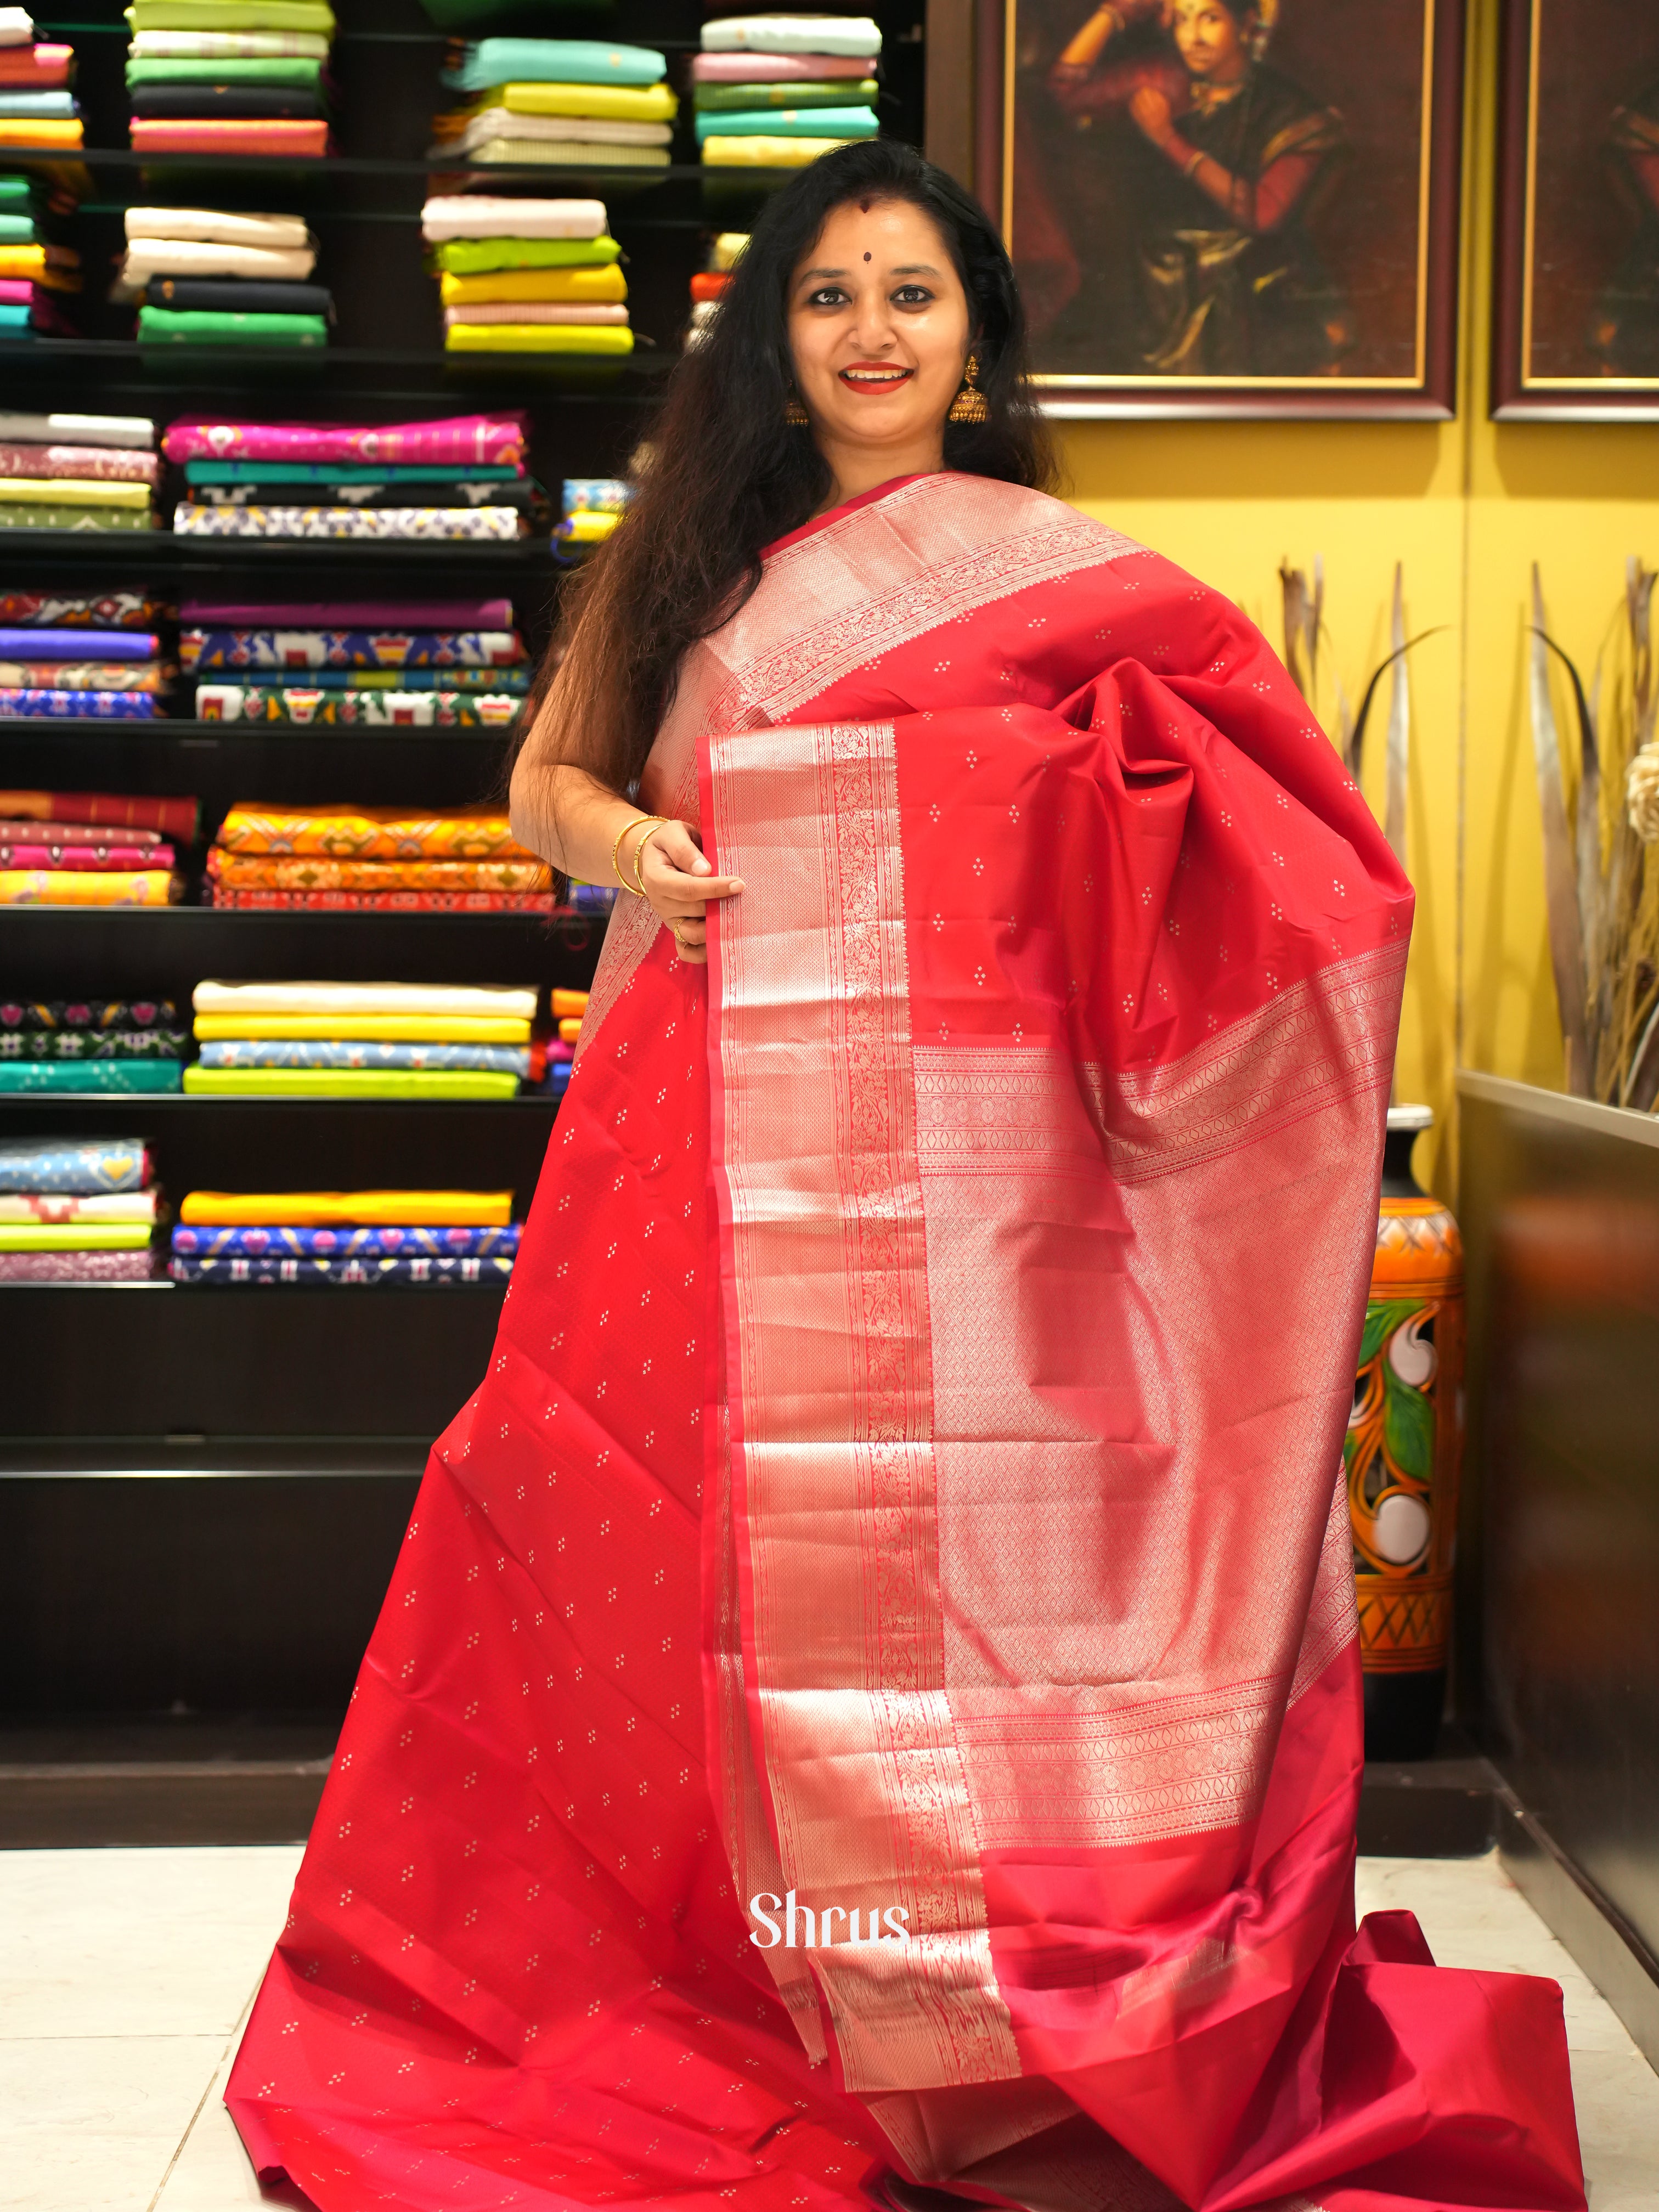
[[973, 0, 1464, 418]]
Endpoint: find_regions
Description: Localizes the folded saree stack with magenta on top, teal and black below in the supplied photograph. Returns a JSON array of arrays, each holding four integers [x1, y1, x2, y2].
[[161, 414, 542, 539]]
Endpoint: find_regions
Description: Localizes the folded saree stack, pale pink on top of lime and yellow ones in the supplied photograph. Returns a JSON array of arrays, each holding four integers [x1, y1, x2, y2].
[[420, 193, 633, 356]]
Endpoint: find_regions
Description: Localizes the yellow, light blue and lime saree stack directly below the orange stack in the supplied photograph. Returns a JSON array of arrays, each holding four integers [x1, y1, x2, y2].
[[184, 982, 542, 1097]]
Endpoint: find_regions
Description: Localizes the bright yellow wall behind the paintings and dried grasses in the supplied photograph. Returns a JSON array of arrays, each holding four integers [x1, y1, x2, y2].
[[1062, 0, 1659, 1197]]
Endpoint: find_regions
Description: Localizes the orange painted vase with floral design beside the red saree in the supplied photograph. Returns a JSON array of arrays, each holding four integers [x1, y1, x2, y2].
[[1342, 1106, 1464, 1758]]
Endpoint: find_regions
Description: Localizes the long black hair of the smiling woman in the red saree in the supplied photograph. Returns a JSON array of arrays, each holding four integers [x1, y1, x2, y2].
[[527, 139, 1053, 792]]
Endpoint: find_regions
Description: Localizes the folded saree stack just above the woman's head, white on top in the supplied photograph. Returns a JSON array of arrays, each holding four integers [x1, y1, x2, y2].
[[692, 15, 881, 168]]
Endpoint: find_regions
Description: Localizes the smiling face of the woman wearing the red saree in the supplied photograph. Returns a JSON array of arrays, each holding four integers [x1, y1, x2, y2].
[[789, 199, 971, 447]]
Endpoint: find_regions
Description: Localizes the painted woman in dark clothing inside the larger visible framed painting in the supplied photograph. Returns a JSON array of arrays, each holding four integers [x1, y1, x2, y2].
[[1044, 0, 1354, 376]]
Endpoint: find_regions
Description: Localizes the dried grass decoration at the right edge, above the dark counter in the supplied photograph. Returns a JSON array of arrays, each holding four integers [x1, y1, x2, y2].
[[1531, 555, 1659, 1113]]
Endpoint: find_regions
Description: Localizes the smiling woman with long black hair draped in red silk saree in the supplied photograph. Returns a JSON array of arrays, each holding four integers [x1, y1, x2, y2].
[[228, 142, 1582, 2212]]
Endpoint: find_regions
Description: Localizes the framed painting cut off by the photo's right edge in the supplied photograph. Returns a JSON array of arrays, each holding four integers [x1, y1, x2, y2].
[[1493, 0, 1659, 422]]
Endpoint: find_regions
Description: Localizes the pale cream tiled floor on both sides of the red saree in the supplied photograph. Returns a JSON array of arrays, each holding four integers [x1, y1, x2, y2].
[[0, 1847, 1659, 2212]]
